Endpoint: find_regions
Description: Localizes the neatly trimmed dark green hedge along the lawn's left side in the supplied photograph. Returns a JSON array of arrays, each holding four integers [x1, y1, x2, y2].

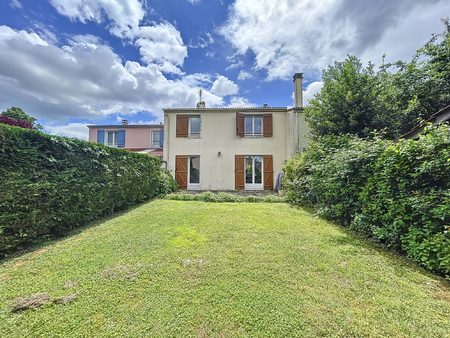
[[0, 124, 176, 256]]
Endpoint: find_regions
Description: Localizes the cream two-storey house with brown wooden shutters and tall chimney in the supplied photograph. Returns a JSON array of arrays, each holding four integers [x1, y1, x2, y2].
[[163, 73, 308, 190]]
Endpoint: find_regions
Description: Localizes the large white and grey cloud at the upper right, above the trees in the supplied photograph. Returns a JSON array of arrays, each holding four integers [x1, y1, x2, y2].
[[220, 0, 450, 80]]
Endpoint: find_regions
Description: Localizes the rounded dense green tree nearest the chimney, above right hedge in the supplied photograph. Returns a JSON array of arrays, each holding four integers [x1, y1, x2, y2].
[[305, 55, 387, 137]]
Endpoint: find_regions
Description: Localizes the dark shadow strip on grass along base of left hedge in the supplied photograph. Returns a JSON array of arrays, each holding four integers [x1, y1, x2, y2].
[[0, 198, 158, 267]]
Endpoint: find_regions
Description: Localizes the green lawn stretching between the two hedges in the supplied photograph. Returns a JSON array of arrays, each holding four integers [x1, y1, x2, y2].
[[0, 200, 450, 337]]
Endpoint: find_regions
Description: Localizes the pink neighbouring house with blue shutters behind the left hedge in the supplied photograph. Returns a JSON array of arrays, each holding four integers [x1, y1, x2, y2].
[[88, 120, 164, 159]]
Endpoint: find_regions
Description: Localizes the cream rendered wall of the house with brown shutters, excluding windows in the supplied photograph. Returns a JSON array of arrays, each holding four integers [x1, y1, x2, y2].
[[164, 110, 287, 190]]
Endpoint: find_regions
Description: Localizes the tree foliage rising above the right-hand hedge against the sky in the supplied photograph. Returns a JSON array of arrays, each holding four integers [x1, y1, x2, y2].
[[305, 20, 450, 139]]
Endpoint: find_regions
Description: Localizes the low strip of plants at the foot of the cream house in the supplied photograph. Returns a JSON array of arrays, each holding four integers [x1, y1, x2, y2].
[[165, 191, 286, 203]]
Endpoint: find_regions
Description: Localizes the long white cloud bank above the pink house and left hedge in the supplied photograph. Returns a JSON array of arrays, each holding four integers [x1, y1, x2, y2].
[[0, 26, 225, 127]]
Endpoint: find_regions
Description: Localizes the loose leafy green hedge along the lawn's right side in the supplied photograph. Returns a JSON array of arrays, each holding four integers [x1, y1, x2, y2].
[[284, 125, 450, 277]]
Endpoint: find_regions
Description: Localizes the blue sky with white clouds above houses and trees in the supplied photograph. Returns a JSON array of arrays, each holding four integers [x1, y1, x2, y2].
[[0, 0, 450, 139]]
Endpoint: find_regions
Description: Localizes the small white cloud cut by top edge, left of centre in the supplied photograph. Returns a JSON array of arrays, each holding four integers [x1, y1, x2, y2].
[[50, 0, 145, 37]]
